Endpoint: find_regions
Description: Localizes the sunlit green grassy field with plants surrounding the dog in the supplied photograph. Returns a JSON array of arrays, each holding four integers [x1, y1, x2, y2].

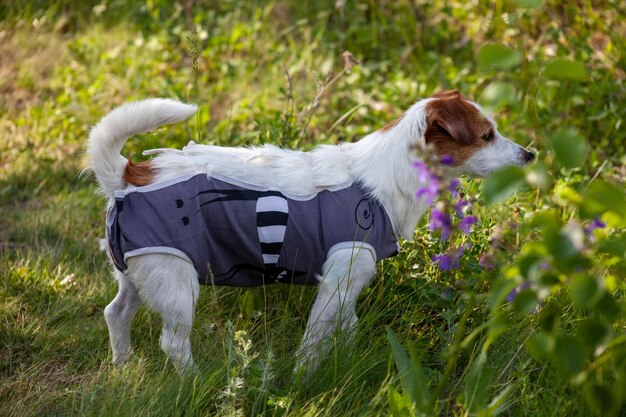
[[0, 0, 626, 417]]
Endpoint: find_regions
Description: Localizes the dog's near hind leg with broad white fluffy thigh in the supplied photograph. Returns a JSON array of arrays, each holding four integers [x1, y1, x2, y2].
[[127, 254, 200, 372]]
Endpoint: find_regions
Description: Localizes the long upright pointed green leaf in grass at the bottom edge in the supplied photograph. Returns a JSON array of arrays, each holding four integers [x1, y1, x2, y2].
[[387, 328, 433, 413]]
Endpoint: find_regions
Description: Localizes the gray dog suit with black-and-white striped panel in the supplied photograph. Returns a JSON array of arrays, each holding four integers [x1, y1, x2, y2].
[[107, 174, 398, 287]]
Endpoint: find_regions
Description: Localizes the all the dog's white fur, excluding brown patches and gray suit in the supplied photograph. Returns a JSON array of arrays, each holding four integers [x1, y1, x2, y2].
[[88, 99, 525, 370]]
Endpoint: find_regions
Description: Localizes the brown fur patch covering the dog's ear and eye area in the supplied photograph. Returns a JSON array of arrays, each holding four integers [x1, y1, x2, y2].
[[424, 90, 493, 166]]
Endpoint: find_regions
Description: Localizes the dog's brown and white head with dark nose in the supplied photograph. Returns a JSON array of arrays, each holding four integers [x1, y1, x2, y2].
[[424, 90, 535, 176]]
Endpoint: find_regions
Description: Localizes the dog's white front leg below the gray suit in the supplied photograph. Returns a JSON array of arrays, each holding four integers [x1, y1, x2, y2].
[[298, 244, 376, 371]]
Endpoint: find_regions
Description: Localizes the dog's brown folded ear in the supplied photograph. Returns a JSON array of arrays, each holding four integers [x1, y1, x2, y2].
[[424, 90, 472, 145]]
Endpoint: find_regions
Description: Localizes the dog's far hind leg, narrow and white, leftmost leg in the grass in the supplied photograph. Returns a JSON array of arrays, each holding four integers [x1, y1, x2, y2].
[[104, 271, 141, 365]]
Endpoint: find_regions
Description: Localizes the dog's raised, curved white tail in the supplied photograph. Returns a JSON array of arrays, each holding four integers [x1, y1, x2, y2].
[[87, 98, 198, 195]]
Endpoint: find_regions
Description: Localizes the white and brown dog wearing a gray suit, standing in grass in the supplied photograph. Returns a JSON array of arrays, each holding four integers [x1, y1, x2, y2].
[[88, 90, 535, 372]]
